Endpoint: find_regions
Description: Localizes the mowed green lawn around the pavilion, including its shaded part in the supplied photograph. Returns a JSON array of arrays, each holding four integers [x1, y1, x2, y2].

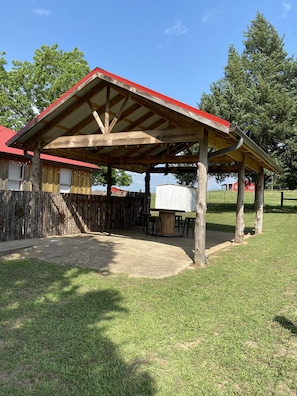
[[0, 192, 297, 396]]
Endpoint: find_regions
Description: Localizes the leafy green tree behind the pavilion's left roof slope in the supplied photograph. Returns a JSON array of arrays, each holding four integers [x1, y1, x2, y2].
[[0, 44, 132, 186]]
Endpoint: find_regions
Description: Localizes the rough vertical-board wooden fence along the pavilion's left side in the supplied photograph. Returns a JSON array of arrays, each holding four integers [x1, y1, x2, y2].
[[0, 191, 145, 241]]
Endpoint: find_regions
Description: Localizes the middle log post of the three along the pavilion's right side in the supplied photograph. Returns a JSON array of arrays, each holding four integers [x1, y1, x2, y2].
[[235, 162, 245, 243]]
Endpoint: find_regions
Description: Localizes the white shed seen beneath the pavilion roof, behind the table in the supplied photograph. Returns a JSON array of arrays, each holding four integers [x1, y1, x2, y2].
[[155, 184, 197, 212]]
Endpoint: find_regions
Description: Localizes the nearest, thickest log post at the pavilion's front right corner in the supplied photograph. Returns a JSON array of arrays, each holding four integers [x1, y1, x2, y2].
[[194, 131, 208, 267]]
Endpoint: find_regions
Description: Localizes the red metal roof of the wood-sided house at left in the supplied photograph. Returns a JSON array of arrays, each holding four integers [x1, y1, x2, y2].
[[0, 125, 98, 169]]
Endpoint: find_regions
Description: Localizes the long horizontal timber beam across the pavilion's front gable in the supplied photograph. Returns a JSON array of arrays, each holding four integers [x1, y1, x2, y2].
[[43, 127, 202, 149]]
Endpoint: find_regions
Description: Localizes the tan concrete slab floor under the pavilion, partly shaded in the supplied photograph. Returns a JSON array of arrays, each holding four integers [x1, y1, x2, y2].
[[0, 230, 234, 278]]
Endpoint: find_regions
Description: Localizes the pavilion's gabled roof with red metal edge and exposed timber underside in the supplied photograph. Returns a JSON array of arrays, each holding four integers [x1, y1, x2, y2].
[[7, 68, 280, 173]]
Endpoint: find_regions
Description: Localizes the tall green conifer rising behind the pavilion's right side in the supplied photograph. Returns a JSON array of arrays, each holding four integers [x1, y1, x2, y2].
[[199, 13, 297, 187]]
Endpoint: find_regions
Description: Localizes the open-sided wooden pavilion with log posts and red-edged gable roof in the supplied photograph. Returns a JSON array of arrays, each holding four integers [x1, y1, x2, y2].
[[7, 68, 281, 266]]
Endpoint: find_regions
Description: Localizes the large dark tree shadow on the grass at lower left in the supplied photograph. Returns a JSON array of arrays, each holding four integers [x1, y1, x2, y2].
[[0, 260, 155, 396]]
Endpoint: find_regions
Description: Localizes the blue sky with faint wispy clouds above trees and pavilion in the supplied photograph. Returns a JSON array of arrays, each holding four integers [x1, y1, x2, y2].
[[0, 0, 297, 191]]
